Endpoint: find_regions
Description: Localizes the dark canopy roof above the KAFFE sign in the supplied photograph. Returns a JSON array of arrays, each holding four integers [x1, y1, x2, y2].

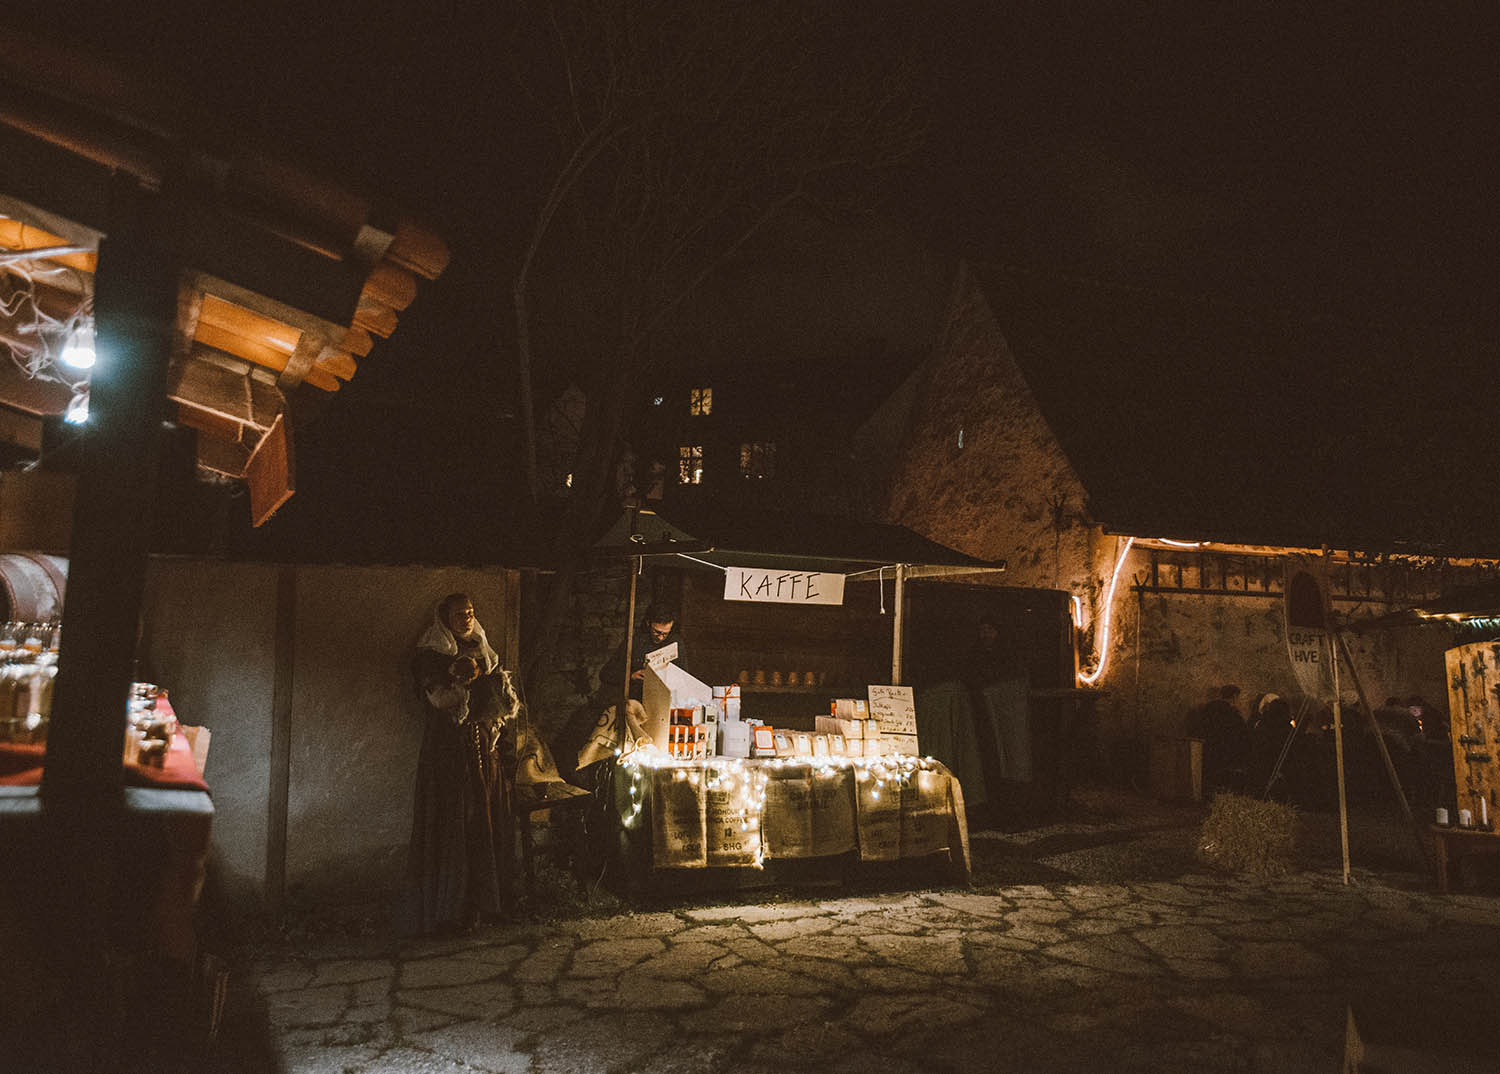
[[594, 504, 1005, 578]]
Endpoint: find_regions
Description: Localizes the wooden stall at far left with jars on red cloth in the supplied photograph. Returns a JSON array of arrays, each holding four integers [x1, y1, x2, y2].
[[0, 24, 449, 1070]]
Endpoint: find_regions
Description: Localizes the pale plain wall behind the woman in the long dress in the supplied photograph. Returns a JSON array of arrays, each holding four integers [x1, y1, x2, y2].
[[143, 560, 519, 900]]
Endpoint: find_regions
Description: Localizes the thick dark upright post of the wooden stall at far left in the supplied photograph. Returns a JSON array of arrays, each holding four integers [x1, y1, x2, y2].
[[35, 179, 179, 1070]]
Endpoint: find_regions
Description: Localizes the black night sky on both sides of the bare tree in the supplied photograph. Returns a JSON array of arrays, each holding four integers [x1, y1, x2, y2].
[[17, 10, 1500, 555]]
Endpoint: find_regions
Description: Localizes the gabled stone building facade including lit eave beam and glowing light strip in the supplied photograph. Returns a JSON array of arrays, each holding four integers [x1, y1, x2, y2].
[[858, 267, 1496, 738]]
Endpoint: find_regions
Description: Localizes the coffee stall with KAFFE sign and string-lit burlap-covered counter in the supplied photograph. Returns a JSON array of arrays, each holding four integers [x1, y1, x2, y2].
[[596, 512, 1002, 890]]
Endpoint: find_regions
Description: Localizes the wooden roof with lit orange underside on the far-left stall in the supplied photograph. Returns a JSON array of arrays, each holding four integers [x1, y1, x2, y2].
[[0, 27, 449, 525]]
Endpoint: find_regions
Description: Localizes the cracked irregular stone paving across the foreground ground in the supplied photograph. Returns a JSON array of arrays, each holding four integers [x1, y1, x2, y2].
[[228, 870, 1500, 1074]]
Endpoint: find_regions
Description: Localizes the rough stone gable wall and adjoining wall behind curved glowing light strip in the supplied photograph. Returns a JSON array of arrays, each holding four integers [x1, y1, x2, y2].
[[858, 269, 1449, 750]]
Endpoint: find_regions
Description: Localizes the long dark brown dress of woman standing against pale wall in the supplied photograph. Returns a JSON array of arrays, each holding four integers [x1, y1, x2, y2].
[[398, 638, 515, 935]]
